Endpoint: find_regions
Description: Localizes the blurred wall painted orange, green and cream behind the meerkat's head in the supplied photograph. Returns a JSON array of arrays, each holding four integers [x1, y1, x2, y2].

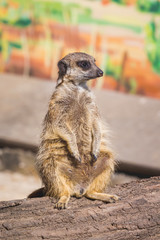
[[0, 0, 160, 98]]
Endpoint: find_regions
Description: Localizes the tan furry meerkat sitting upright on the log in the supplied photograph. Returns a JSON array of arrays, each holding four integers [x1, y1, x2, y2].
[[29, 52, 118, 209]]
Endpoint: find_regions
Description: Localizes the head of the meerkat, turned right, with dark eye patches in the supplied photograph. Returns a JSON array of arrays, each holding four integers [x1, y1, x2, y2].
[[58, 52, 103, 85]]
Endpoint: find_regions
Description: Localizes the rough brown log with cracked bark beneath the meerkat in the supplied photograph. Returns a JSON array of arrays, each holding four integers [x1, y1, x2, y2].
[[0, 177, 160, 240]]
